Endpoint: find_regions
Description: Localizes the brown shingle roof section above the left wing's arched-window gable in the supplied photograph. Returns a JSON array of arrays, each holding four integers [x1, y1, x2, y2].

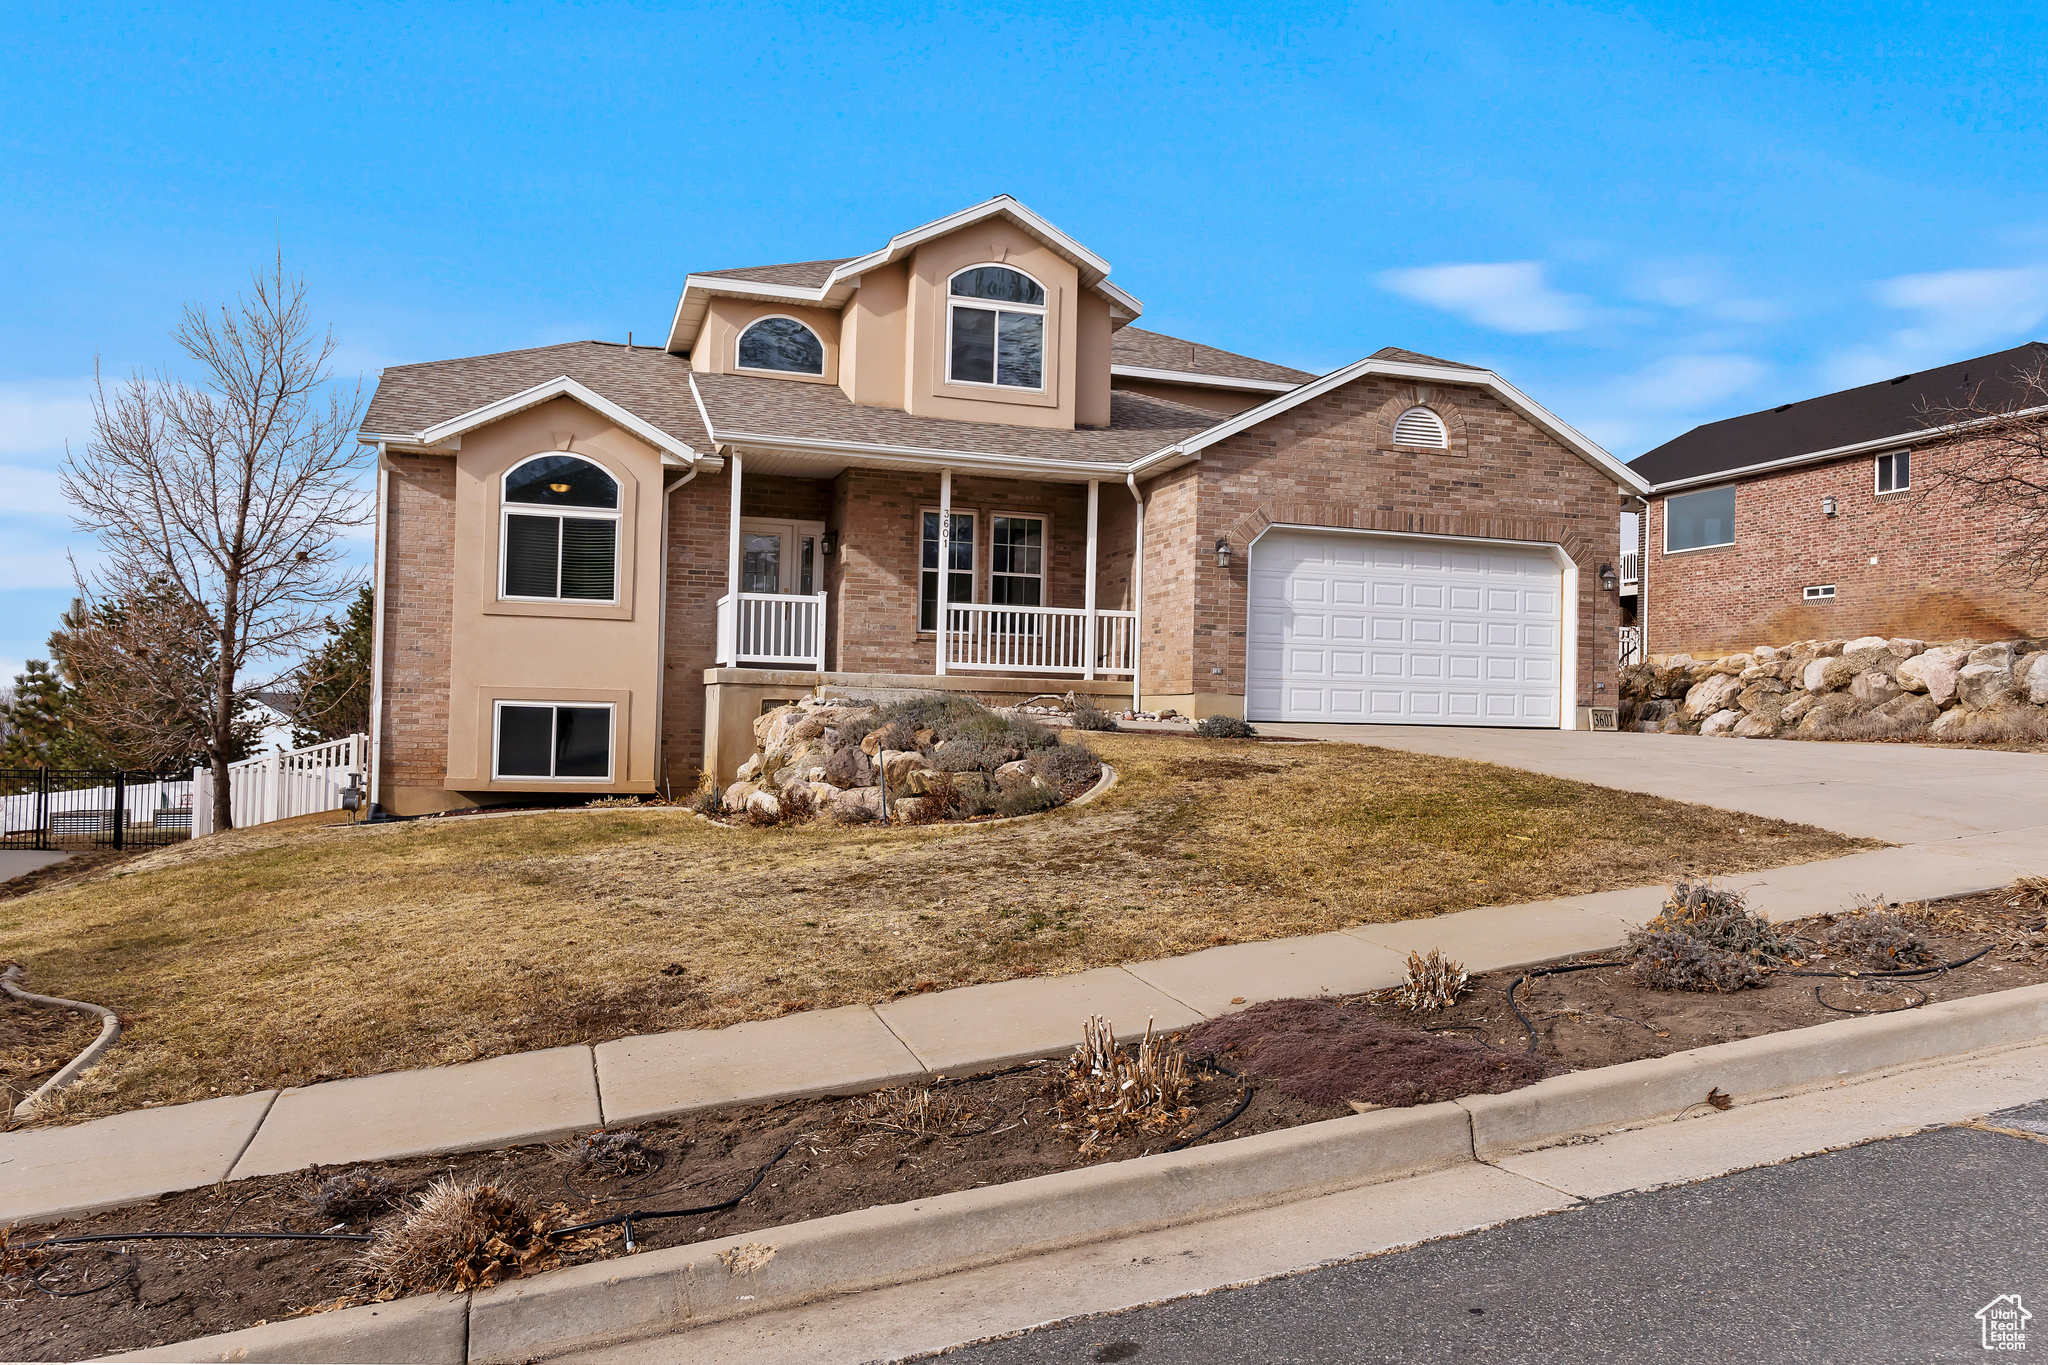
[[362, 342, 712, 452]]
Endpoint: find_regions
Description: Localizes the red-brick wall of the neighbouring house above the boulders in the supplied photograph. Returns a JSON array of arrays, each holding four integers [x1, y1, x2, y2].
[[1642, 435, 2048, 655]]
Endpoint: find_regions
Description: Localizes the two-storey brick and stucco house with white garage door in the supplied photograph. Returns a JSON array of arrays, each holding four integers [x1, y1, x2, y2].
[[360, 196, 1647, 814]]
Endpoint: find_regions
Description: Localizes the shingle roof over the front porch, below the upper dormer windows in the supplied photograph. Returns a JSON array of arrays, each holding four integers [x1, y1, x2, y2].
[[696, 375, 1217, 463]]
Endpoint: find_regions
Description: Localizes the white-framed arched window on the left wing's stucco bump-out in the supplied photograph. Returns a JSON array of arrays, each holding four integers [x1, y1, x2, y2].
[[498, 454, 618, 602]]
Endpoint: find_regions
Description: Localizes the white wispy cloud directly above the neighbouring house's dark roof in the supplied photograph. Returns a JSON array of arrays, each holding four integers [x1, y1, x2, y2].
[[1821, 266, 2048, 387]]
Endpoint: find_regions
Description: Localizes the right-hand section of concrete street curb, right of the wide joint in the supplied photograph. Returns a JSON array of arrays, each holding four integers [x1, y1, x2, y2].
[[1458, 984, 2048, 1160]]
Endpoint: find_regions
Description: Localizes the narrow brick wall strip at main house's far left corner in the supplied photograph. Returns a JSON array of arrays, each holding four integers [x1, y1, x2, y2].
[[379, 454, 455, 790]]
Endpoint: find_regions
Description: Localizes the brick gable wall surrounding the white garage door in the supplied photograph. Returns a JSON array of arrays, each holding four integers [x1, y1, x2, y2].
[[1145, 377, 1620, 706]]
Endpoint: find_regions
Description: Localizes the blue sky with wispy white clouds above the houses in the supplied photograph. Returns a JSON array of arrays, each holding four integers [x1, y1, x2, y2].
[[0, 0, 2048, 677]]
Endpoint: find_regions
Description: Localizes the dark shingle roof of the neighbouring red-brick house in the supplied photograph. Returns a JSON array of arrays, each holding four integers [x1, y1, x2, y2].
[[1628, 342, 2048, 485]]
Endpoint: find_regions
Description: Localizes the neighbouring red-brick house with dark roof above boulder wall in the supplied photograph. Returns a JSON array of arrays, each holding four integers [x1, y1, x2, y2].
[[1630, 342, 2048, 657]]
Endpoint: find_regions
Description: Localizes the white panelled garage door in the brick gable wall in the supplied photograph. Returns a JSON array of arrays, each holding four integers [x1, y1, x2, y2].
[[1245, 530, 1563, 726]]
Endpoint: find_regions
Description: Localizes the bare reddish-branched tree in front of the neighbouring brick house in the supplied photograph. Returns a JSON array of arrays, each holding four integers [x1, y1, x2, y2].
[[1921, 358, 2048, 585]]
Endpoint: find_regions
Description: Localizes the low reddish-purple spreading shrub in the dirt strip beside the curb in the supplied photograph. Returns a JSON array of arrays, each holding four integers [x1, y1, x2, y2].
[[1186, 999, 1552, 1105]]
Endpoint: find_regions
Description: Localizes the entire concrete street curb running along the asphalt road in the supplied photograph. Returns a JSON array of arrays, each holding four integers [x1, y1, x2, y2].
[[109, 984, 2048, 1365]]
